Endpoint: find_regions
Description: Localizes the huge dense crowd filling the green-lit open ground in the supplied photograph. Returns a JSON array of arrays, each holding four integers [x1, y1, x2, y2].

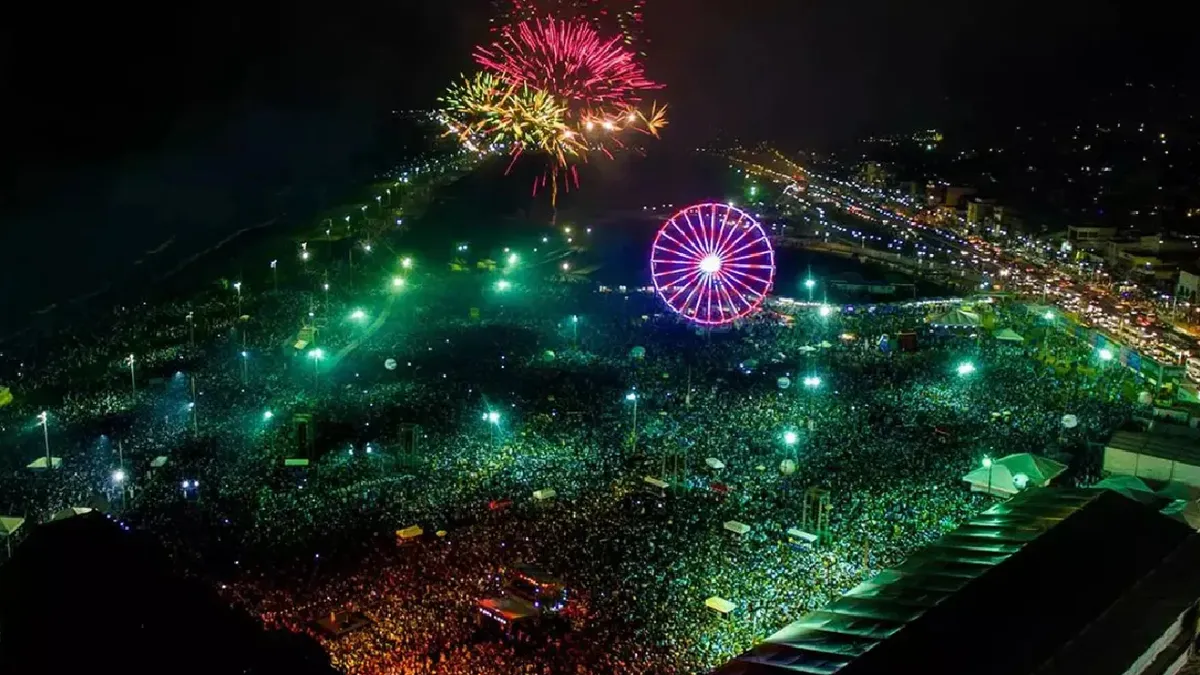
[[0, 169, 1132, 675]]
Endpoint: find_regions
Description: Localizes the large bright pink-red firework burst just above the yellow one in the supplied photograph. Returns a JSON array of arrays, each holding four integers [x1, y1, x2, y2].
[[475, 19, 660, 106]]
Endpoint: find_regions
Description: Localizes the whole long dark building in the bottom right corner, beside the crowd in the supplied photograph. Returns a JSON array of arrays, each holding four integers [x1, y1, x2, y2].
[[715, 488, 1200, 675]]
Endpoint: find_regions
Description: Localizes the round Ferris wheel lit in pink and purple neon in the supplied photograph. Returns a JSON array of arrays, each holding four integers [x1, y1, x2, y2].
[[650, 203, 775, 325]]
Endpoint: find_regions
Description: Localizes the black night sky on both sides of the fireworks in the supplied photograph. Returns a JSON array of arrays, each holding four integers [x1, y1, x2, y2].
[[0, 0, 1196, 324]]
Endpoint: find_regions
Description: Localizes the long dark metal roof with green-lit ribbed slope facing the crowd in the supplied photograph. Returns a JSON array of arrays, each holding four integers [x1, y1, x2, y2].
[[715, 489, 1200, 675]]
